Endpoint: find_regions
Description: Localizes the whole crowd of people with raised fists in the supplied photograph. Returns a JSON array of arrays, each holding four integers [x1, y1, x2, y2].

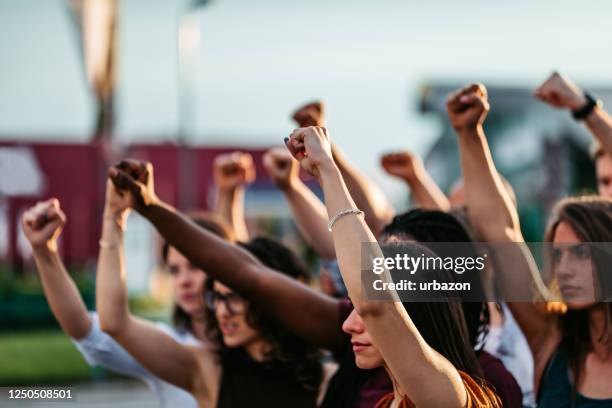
[[23, 73, 612, 408]]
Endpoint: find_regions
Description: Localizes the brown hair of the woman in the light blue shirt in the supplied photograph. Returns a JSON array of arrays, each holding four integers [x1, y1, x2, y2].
[[161, 211, 236, 332]]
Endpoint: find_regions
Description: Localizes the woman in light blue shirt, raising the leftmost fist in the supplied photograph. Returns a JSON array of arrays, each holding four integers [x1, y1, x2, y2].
[[22, 199, 233, 407]]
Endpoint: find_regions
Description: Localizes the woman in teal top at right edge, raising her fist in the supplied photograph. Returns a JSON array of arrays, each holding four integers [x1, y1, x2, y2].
[[447, 84, 612, 408]]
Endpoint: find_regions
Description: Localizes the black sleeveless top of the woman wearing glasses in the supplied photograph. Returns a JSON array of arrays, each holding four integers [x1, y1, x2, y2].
[[217, 349, 319, 408]]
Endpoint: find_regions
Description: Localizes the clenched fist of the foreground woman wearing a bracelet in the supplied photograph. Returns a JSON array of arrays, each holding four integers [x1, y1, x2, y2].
[[285, 126, 334, 178]]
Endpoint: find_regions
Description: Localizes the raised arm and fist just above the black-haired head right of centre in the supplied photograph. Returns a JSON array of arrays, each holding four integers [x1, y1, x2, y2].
[[381, 152, 451, 211]]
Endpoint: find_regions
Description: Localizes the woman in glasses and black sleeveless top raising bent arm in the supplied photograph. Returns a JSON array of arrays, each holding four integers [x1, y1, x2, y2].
[[96, 180, 323, 407]]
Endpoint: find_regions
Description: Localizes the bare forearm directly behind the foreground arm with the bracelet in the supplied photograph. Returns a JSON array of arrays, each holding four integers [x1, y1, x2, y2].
[[333, 146, 395, 236]]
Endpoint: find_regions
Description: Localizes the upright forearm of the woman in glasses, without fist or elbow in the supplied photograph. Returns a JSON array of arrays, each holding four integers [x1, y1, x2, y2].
[[96, 216, 130, 337]]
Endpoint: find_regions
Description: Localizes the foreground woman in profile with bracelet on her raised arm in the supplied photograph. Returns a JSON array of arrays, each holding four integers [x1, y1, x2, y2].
[[286, 127, 499, 407]]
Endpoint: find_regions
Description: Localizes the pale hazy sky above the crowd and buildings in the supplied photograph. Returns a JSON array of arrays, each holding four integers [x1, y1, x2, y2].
[[0, 0, 612, 201]]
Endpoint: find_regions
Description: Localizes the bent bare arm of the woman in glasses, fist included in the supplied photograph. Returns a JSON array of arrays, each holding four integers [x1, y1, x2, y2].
[[96, 182, 201, 392]]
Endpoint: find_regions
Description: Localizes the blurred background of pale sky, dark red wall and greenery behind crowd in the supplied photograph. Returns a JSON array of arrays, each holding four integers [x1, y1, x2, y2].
[[0, 0, 612, 403]]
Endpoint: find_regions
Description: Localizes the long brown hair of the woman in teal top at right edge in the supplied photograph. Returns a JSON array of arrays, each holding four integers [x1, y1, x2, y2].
[[544, 196, 612, 394]]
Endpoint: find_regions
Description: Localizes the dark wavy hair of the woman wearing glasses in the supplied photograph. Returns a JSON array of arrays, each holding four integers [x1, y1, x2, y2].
[[204, 237, 323, 391]]
